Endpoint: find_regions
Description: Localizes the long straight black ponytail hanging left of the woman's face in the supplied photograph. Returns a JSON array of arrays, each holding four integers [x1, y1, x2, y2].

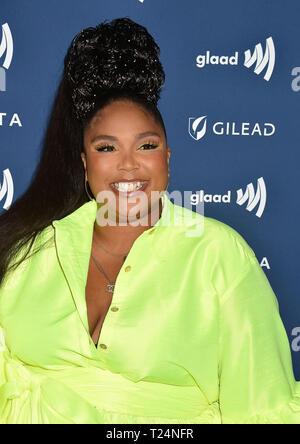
[[0, 74, 89, 286]]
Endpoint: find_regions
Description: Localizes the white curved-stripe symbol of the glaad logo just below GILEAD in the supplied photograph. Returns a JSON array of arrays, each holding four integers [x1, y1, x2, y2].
[[236, 177, 267, 217]]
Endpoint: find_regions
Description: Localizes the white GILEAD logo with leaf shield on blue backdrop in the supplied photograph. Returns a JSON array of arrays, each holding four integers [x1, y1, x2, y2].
[[188, 116, 275, 141]]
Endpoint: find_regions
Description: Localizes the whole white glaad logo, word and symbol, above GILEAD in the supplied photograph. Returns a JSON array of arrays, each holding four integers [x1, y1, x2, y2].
[[196, 37, 275, 81]]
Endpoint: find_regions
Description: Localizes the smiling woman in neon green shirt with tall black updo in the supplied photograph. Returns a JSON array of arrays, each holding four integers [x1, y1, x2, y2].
[[0, 18, 300, 424]]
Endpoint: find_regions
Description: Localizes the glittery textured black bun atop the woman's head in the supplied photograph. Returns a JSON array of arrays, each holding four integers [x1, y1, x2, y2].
[[65, 18, 165, 120]]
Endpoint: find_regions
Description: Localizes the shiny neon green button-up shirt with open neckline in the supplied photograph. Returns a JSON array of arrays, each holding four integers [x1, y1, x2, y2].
[[0, 194, 300, 424]]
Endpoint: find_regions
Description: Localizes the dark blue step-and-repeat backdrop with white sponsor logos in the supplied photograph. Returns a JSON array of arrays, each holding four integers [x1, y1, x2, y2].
[[0, 0, 300, 380]]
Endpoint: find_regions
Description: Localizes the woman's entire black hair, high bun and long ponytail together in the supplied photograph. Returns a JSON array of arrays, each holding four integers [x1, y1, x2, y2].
[[0, 17, 166, 285]]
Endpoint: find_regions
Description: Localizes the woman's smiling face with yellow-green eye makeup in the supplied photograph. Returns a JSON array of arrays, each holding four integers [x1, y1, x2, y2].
[[81, 99, 171, 225]]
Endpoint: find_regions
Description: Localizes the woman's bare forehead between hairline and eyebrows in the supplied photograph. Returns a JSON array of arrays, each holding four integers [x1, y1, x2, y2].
[[85, 100, 162, 136]]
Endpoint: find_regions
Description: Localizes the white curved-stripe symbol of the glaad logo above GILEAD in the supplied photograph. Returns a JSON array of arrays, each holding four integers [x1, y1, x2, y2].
[[244, 37, 275, 81]]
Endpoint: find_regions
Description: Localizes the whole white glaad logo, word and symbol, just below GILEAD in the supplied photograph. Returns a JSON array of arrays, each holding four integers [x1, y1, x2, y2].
[[190, 177, 267, 217]]
